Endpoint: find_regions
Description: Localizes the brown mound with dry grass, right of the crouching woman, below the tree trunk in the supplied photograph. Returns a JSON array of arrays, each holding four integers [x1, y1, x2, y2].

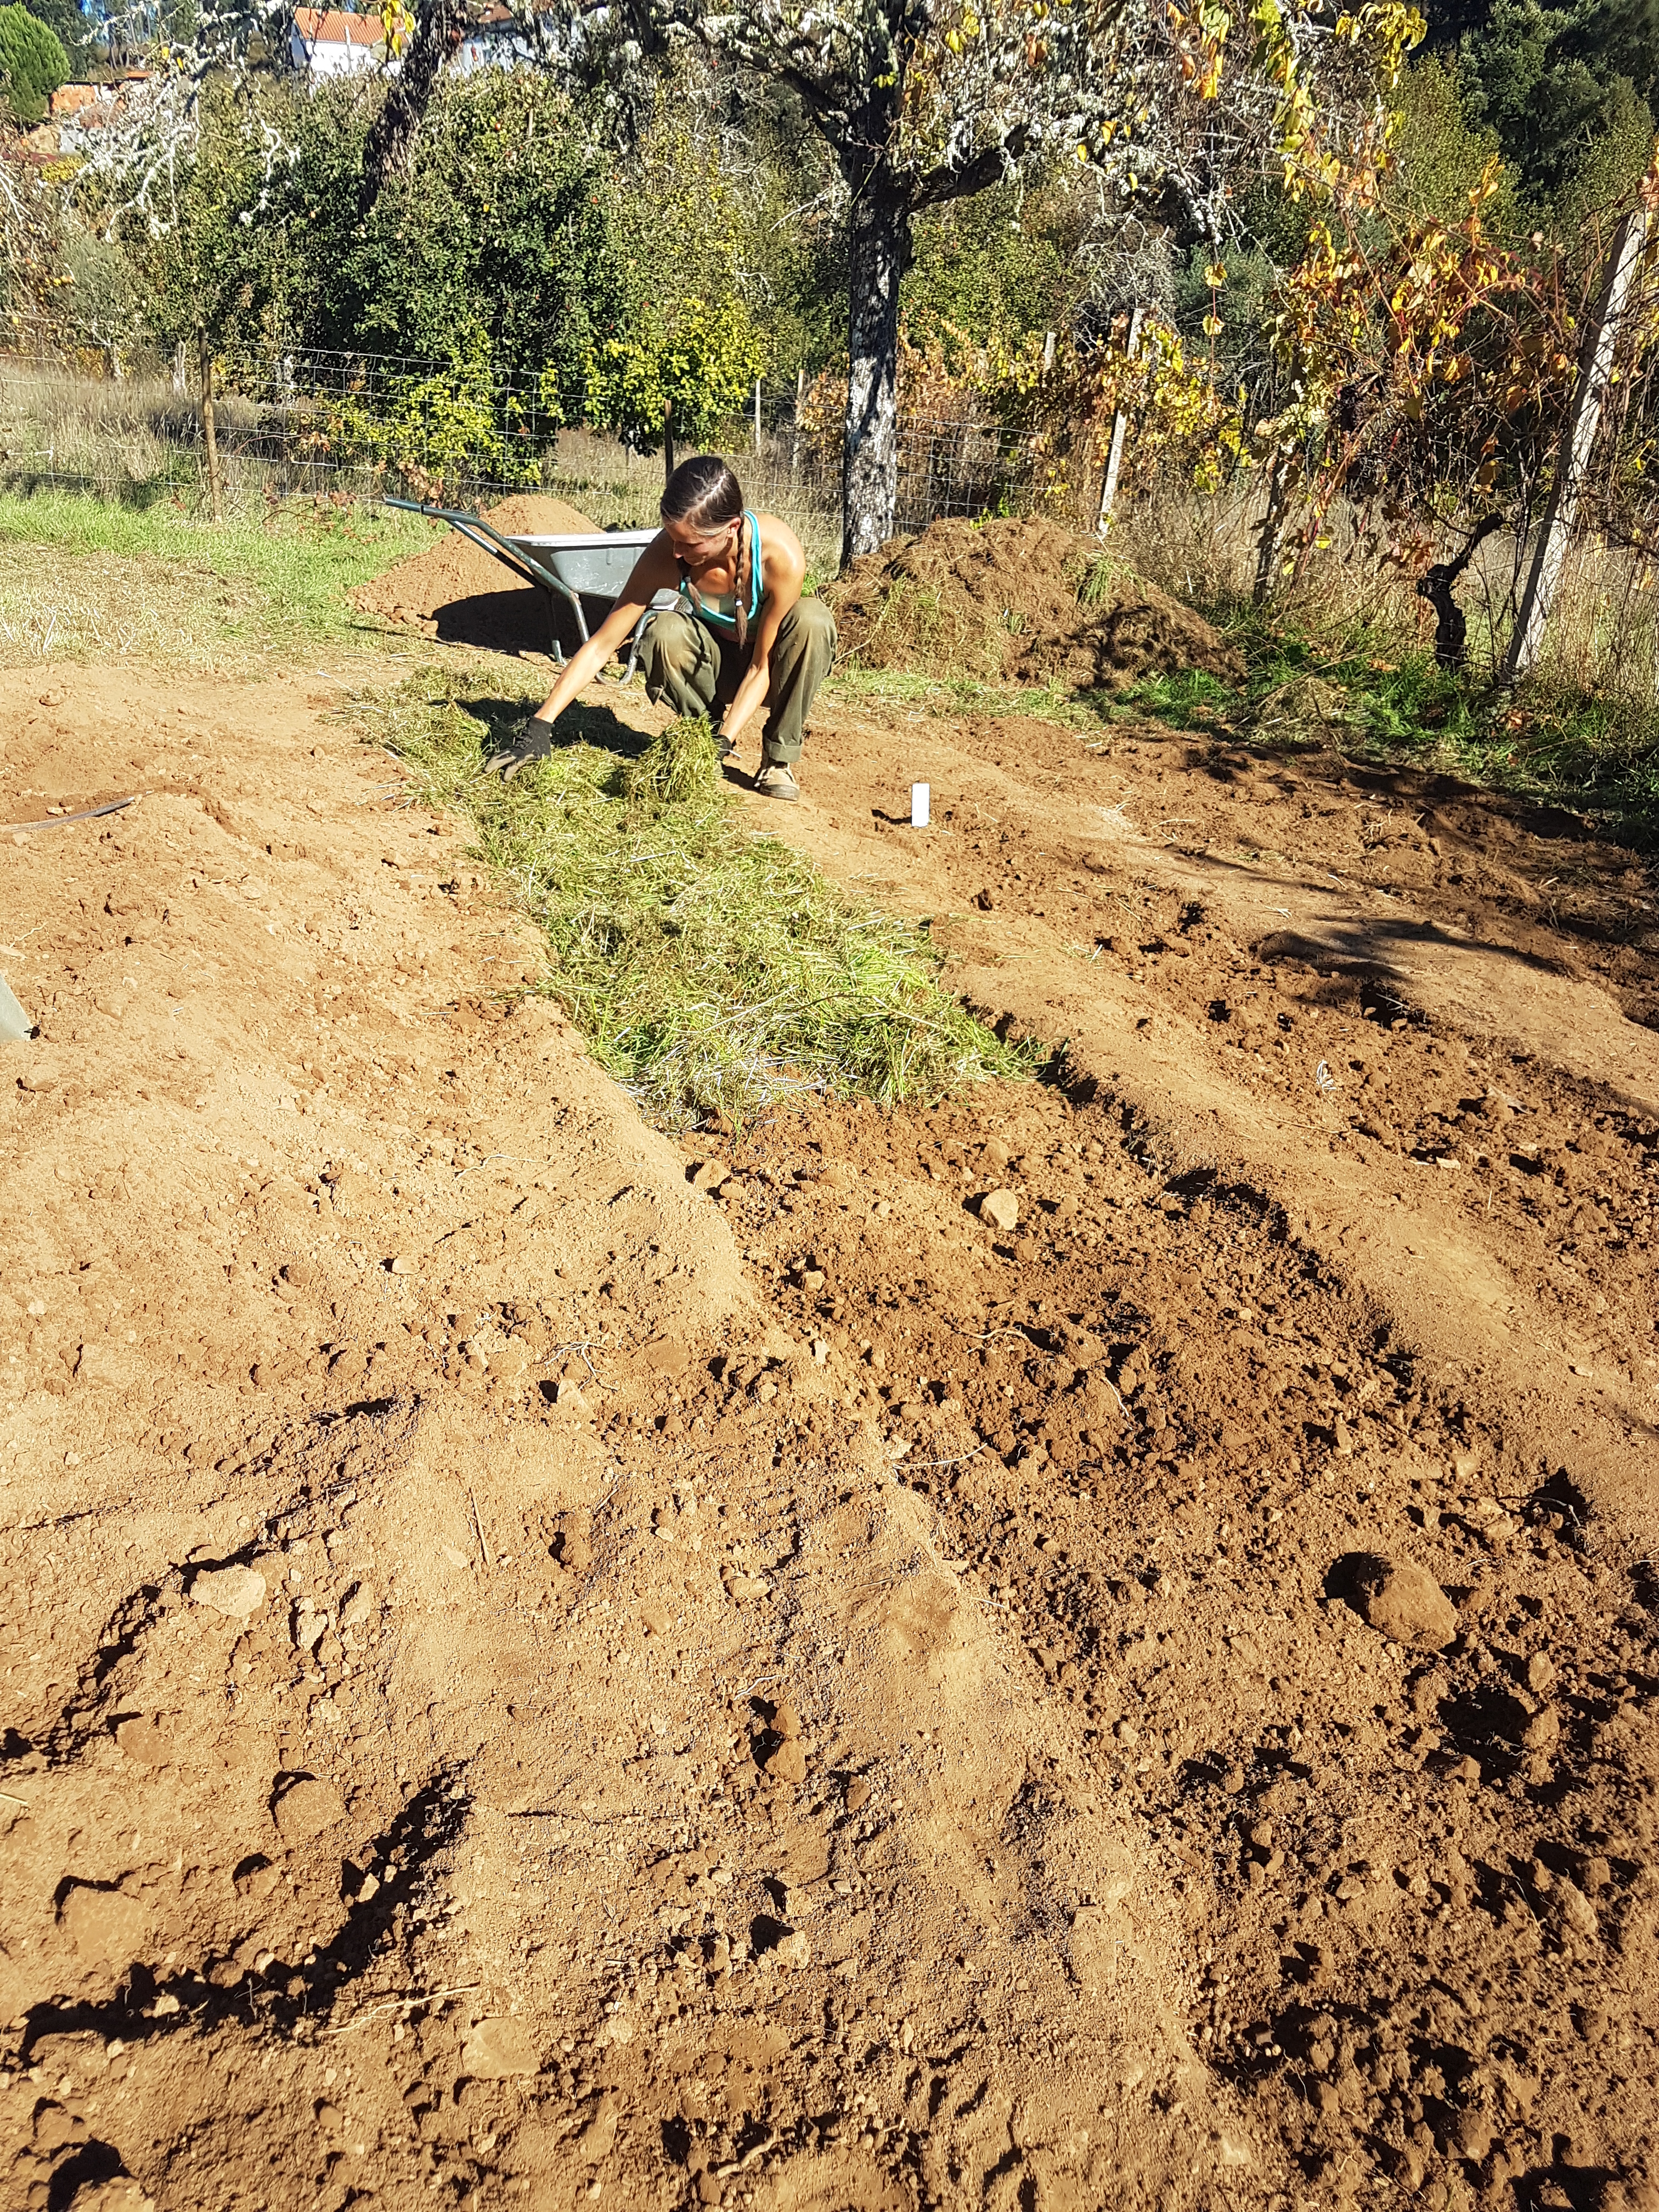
[[825, 515, 1243, 690]]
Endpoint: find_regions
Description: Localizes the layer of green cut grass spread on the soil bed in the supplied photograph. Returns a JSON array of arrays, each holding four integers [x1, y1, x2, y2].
[[376, 673, 1040, 1128]]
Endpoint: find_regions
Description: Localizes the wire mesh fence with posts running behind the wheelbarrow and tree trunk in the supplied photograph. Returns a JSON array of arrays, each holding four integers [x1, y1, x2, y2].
[[0, 321, 1106, 557]]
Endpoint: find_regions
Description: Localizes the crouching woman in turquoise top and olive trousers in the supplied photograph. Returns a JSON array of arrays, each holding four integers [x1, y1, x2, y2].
[[489, 454, 836, 799]]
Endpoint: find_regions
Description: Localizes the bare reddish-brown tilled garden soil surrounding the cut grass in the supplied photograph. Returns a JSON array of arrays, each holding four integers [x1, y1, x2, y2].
[[0, 628, 1659, 2212]]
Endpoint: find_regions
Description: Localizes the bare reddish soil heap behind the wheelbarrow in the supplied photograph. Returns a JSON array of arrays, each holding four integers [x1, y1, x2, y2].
[[352, 493, 600, 652]]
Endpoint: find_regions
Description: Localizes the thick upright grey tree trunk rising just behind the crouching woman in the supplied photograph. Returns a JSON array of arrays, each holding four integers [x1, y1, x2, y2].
[[840, 159, 909, 568]]
